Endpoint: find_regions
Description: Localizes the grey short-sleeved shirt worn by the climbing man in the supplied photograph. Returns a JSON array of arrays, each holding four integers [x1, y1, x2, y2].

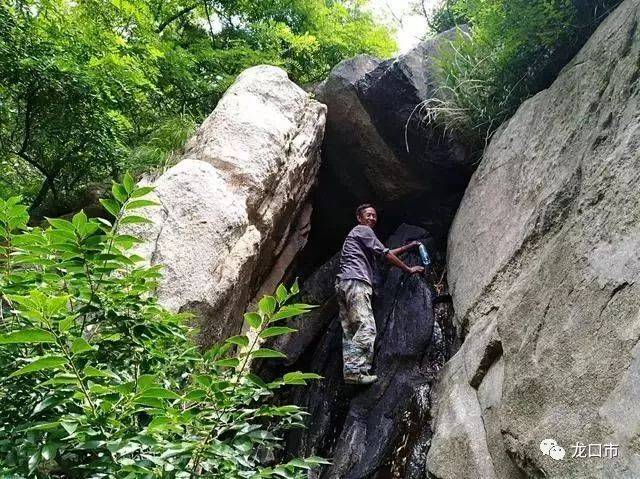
[[338, 225, 389, 286]]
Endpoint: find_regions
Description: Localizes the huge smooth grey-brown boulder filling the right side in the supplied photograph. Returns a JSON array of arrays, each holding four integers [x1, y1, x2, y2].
[[428, 0, 640, 479]]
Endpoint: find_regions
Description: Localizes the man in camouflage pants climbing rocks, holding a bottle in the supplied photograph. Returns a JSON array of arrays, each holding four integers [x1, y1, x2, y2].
[[336, 204, 424, 384]]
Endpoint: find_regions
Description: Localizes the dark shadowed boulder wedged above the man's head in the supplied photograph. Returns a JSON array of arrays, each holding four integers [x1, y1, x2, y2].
[[311, 26, 473, 259]]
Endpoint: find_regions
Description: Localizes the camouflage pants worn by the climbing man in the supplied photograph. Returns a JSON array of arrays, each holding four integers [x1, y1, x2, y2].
[[336, 279, 376, 374]]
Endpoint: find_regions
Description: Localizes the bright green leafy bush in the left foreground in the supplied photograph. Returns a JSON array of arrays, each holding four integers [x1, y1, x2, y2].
[[0, 175, 323, 479]]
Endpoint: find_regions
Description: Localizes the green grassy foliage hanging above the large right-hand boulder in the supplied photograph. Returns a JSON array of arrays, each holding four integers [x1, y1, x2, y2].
[[425, 0, 620, 153]]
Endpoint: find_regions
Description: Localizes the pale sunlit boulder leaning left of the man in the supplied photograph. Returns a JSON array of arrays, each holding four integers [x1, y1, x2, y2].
[[138, 66, 326, 342]]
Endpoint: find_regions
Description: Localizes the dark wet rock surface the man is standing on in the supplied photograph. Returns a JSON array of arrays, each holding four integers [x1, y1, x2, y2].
[[262, 225, 453, 479]]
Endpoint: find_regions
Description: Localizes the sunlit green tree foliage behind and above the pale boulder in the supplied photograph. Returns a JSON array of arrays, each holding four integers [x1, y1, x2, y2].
[[0, 0, 394, 213]]
